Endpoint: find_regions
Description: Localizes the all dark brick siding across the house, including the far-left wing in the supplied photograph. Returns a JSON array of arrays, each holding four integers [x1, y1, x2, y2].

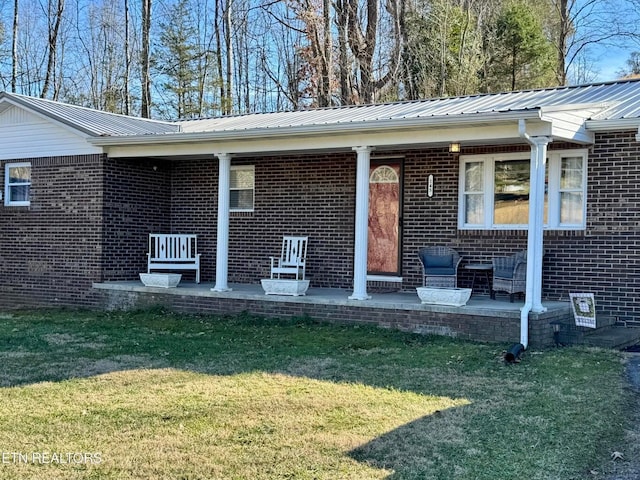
[[0, 131, 640, 324]]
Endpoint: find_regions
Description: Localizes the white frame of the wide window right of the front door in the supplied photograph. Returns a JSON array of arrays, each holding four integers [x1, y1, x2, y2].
[[458, 149, 588, 230]]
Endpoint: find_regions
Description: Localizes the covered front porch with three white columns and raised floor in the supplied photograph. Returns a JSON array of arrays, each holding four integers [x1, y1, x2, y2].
[[92, 88, 616, 347]]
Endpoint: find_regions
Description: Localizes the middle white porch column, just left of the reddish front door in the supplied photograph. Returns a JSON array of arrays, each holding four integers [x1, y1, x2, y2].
[[349, 147, 373, 300]]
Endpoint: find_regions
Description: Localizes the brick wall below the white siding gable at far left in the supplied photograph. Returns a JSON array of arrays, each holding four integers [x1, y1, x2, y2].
[[0, 155, 103, 307]]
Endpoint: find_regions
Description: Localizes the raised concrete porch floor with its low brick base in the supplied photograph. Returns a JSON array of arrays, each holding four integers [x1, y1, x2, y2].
[[93, 281, 571, 346]]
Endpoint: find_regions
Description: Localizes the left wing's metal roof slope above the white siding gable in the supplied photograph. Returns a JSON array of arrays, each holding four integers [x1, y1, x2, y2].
[[0, 92, 180, 136]]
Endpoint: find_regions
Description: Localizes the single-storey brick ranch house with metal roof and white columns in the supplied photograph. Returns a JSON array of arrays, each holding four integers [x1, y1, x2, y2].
[[0, 80, 640, 346]]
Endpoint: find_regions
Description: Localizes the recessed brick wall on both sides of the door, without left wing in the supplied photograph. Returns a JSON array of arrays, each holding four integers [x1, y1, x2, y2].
[[165, 139, 640, 322]]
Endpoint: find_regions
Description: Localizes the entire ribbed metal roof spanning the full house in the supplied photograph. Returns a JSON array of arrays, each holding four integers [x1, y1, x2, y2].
[[0, 79, 640, 138]]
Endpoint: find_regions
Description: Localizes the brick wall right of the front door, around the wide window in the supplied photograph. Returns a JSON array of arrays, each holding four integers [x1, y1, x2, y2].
[[403, 137, 640, 325]]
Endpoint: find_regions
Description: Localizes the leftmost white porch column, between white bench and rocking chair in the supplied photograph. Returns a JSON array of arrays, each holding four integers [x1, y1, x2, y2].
[[211, 153, 231, 292]]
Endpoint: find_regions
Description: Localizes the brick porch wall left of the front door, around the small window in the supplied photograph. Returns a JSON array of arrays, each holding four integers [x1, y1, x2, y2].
[[172, 154, 355, 288]]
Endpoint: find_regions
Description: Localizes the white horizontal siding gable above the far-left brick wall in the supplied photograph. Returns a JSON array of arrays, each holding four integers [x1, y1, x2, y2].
[[0, 106, 102, 160]]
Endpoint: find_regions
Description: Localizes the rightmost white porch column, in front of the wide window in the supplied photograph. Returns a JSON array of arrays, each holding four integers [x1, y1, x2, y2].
[[525, 137, 551, 313]]
